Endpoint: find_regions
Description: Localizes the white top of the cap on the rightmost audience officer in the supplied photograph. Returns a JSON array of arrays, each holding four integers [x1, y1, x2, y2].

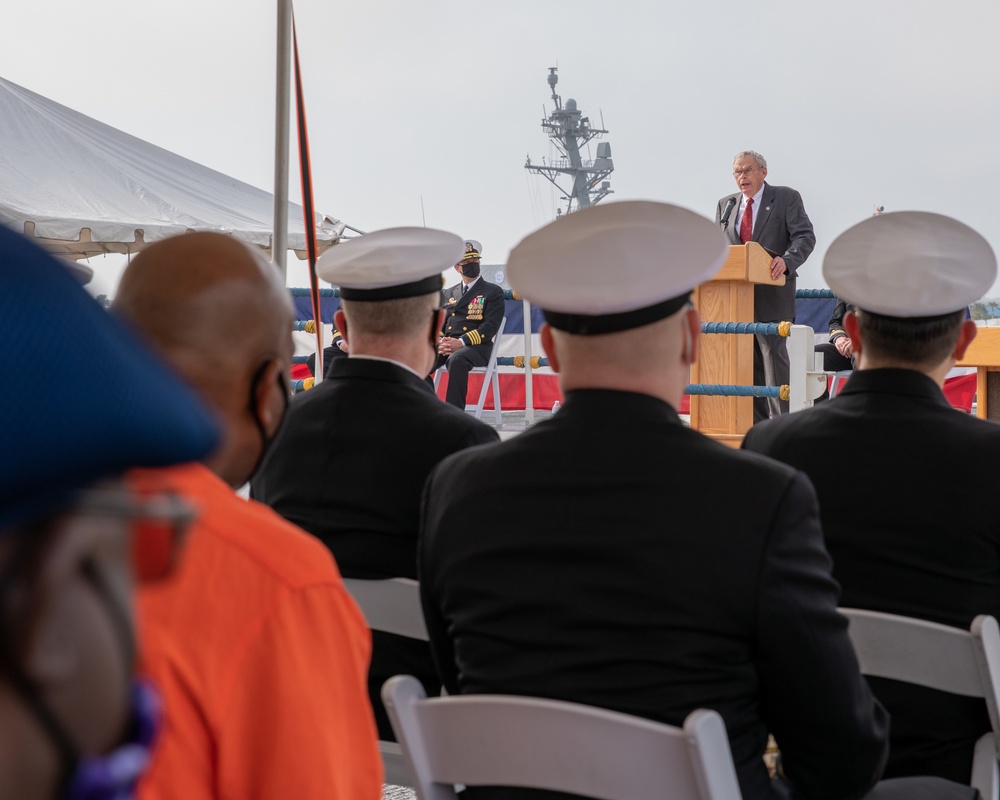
[[823, 211, 997, 319]]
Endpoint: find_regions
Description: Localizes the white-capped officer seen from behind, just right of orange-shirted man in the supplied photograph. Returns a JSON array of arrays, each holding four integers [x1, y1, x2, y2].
[[251, 228, 498, 739]]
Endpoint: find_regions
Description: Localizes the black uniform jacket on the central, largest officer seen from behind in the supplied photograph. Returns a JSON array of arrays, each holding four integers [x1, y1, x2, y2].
[[419, 390, 887, 800]]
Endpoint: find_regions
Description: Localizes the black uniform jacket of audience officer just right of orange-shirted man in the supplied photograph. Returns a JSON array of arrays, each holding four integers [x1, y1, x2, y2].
[[251, 358, 498, 738]]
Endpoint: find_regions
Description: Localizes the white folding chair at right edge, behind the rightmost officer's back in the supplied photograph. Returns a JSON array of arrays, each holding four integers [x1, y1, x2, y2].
[[840, 608, 1000, 800]]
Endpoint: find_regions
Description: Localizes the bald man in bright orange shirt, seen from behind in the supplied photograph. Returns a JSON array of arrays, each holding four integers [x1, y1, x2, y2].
[[115, 233, 382, 800]]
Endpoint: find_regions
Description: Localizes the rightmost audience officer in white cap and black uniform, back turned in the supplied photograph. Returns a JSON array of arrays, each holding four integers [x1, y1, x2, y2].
[[744, 212, 1000, 782]]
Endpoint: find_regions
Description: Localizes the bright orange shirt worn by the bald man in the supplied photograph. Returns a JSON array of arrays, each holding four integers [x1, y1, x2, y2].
[[133, 464, 382, 800]]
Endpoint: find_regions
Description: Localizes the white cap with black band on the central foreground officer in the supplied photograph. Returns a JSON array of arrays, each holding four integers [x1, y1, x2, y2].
[[507, 200, 729, 335]]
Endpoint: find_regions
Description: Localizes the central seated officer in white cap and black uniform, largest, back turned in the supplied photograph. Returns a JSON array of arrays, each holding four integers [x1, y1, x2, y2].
[[419, 202, 972, 800]]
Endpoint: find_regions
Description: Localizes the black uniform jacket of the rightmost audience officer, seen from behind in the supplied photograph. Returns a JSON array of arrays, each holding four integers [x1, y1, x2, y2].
[[743, 369, 1000, 783]]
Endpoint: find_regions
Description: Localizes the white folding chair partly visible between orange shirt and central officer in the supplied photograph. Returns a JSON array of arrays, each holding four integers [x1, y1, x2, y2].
[[344, 578, 427, 786]]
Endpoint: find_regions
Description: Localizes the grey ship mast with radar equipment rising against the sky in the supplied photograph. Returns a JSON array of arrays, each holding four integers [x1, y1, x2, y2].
[[524, 67, 615, 215]]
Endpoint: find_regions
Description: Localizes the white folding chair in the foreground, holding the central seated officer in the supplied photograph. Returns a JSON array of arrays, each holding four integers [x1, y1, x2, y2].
[[382, 675, 740, 800]]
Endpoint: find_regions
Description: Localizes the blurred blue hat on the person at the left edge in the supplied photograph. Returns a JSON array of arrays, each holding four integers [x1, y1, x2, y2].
[[0, 225, 219, 535]]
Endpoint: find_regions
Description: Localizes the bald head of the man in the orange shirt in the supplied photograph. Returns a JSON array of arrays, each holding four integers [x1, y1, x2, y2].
[[114, 233, 295, 482]]
